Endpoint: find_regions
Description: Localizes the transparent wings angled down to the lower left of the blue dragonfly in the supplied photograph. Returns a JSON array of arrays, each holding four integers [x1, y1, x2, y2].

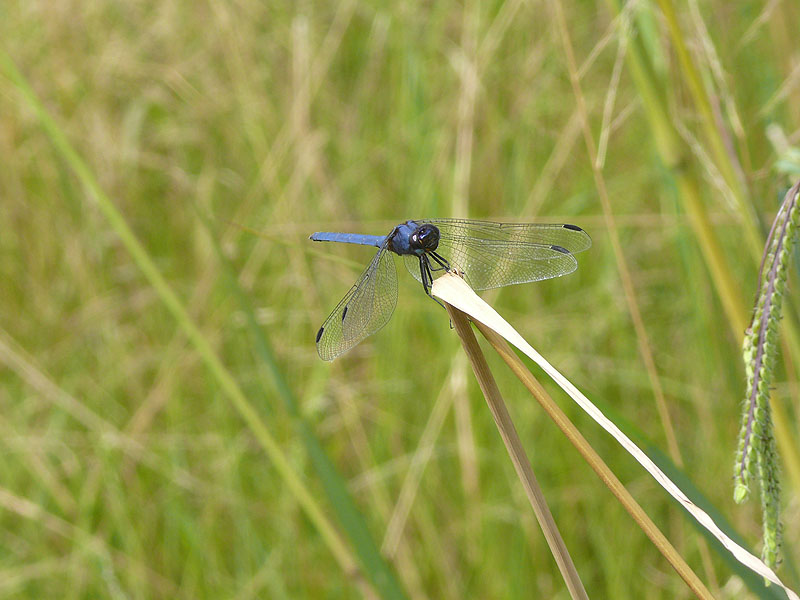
[[317, 246, 397, 360]]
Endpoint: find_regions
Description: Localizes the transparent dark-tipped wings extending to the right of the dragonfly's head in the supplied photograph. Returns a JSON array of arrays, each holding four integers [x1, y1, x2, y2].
[[403, 219, 592, 290]]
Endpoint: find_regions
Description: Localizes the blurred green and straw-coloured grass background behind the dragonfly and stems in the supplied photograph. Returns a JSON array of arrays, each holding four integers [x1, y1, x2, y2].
[[0, 0, 800, 599]]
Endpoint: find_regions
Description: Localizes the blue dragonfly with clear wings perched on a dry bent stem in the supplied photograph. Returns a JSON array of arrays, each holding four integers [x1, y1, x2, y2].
[[311, 219, 592, 360]]
